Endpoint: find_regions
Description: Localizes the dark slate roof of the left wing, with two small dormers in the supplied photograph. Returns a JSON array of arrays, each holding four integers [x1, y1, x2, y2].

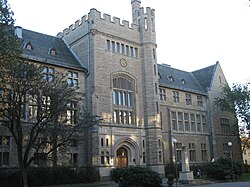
[[22, 29, 86, 70]]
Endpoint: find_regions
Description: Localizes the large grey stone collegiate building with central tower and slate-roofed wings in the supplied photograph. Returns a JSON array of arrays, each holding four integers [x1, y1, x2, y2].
[[0, 0, 241, 177]]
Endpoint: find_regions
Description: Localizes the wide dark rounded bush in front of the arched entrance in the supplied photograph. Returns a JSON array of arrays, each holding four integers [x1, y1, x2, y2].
[[110, 166, 161, 187]]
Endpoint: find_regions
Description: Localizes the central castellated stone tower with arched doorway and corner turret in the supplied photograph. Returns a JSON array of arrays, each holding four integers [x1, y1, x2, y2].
[[58, 0, 164, 179]]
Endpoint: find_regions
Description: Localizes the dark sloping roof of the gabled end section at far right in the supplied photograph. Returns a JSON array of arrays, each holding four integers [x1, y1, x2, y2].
[[192, 62, 218, 90]]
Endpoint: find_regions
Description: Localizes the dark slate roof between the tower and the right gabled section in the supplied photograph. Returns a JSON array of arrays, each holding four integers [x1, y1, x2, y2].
[[158, 64, 206, 95]]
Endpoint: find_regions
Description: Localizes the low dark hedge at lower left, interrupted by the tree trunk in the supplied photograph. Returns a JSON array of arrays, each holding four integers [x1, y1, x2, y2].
[[0, 166, 100, 187]]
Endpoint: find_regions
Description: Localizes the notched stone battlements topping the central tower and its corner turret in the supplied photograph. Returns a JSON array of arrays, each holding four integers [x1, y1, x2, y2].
[[57, 7, 155, 37]]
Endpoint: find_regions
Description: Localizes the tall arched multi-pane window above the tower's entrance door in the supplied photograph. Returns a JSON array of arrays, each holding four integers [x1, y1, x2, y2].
[[113, 76, 135, 125]]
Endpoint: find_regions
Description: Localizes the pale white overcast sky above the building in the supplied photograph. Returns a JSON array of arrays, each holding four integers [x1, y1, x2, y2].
[[8, 0, 250, 85]]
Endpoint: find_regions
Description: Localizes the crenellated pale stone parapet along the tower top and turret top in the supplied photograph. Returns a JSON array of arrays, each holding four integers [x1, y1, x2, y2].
[[57, 7, 155, 37]]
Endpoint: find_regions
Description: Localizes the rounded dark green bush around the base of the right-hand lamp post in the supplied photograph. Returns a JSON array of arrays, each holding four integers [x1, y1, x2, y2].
[[206, 158, 241, 180]]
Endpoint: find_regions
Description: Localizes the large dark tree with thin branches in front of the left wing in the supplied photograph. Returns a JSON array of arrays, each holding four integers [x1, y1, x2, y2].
[[0, 0, 97, 187]]
